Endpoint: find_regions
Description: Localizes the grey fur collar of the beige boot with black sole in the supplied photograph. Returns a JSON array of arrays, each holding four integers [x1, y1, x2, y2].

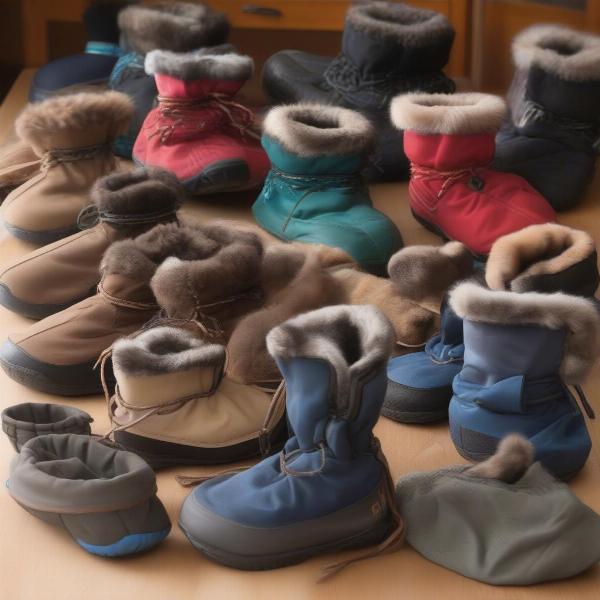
[[112, 327, 225, 376]]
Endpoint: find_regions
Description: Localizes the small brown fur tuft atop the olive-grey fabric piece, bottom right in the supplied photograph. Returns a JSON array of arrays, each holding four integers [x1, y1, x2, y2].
[[465, 433, 535, 483]]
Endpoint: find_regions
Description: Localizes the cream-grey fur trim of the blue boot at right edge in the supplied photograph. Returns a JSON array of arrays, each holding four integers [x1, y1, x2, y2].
[[450, 282, 600, 384]]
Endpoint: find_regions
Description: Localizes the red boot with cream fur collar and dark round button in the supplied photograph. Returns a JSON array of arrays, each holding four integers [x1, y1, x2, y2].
[[391, 93, 556, 256]]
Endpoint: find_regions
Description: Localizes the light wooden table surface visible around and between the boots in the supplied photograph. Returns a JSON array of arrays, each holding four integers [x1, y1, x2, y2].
[[0, 70, 600, 600]]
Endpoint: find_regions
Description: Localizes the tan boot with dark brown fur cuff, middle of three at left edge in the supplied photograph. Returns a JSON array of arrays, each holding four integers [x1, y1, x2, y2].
[[0, 168, 184, 319]]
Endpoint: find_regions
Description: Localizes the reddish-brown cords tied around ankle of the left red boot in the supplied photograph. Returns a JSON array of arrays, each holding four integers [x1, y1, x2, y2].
[[148, 94, 260, 144]]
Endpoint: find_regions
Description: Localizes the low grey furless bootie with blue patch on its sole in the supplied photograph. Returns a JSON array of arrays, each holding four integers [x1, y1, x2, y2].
[[6, 433, 171, 557]]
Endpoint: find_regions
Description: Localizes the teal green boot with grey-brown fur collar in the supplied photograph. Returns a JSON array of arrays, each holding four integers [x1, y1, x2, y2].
[[252, 104, 402, 273]]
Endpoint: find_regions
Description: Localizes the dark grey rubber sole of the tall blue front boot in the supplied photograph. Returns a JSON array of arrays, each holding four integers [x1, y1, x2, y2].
[[179, 523, 392, 571]]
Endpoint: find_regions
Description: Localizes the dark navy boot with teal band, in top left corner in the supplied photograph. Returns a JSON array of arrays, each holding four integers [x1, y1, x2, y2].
[[29, 0, 129, 102]]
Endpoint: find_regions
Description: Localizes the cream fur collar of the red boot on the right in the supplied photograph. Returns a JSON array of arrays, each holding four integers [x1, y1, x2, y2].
[[390, 92, 506, 135]]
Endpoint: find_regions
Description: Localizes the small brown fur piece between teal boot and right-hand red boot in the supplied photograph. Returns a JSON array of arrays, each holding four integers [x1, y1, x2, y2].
[[388, 242, 473, 312]]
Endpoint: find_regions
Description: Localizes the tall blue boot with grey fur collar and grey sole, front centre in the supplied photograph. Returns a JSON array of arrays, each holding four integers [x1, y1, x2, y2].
[[179, 305, 402, 570]]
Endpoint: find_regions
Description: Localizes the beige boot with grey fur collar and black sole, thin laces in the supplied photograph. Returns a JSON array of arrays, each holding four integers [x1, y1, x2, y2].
[[109, 326, 286, 469]]
